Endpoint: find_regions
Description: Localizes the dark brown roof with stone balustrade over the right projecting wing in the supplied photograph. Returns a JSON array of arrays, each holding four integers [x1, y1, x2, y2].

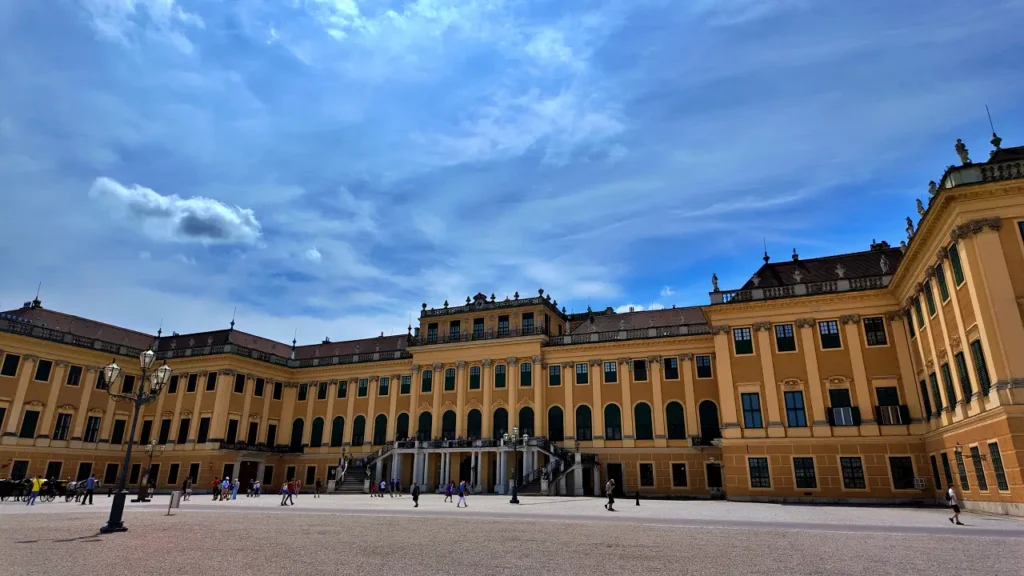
[[741, 247, 903, 290]]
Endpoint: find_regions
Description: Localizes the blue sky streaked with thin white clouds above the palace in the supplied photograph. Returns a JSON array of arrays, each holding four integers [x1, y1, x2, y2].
[[0, 0, 1024, 343]]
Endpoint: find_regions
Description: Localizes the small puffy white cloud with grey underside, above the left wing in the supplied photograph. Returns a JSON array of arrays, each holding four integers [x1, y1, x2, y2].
[[89, 177, 262, 245]]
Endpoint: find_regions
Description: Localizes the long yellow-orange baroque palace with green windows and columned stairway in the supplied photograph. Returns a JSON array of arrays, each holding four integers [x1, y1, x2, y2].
[[6, 140, 1024, 516]]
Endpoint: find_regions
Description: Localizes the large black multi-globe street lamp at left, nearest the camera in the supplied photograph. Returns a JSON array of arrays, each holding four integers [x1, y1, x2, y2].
[[99, 349, 171, 534]]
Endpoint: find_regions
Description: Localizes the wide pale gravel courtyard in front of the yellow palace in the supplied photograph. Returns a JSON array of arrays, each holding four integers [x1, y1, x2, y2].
[[0, 494, 1024, 576]]
